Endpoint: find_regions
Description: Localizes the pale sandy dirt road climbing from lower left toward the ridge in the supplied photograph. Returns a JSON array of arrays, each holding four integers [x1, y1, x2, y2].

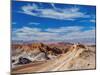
[[12, 49, 86, 73]]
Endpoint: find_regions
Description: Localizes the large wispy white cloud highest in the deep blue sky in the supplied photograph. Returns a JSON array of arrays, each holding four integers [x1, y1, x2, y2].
[[19, 4, 90, 20]]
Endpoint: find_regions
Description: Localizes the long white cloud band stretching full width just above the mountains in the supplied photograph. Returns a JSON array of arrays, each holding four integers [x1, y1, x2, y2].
[[12, 26, 95, 41]]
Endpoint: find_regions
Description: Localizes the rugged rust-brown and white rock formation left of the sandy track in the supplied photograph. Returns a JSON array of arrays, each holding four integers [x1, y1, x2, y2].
[[12, 43, 64, 65]]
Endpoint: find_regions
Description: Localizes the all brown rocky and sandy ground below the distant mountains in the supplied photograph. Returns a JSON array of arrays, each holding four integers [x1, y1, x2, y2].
[[11, 43, 96, 73]]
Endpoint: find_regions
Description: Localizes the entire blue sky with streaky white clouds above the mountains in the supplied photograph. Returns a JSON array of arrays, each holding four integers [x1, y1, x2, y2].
[[11, 1, 96, 41]]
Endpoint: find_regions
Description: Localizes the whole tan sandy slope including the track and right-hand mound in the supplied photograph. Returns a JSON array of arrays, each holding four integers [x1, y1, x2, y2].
[[12, 47, 95, 73]]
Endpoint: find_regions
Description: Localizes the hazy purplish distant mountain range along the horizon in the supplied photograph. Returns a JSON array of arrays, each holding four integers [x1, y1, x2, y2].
[[12, 38, 96, 44]]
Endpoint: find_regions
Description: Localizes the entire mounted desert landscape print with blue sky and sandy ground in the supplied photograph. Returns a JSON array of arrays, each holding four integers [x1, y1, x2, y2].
[[11, 0, 96, 74]]
